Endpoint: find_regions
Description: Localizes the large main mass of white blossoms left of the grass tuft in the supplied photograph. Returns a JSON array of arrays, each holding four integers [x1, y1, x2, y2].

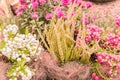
[[0, 25, 41, 60]]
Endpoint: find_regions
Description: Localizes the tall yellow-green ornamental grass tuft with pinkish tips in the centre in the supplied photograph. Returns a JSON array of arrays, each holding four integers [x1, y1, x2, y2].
[[37, 3, 94, 63]]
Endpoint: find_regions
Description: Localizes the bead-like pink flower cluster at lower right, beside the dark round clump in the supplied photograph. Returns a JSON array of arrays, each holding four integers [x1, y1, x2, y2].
[[97, 53, 120, 76]]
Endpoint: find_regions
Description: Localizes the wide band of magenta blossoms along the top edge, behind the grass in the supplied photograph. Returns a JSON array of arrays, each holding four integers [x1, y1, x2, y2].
[[16, 0, 92, 20]]
